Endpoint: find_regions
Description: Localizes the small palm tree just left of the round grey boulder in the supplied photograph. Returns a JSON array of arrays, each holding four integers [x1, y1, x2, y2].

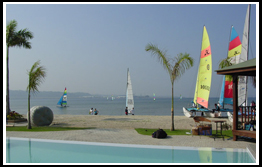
[[26, 61, 46, 129]]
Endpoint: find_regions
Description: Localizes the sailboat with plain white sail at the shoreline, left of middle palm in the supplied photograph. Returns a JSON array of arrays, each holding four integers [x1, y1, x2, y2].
[[126, 68, 134, 113]]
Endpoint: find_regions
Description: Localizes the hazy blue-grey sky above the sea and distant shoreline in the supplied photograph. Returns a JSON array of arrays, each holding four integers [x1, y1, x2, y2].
[[3, 3, 259, 97]]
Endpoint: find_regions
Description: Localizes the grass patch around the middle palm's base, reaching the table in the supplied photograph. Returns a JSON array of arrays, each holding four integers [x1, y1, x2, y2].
[[135, 128, 233, 139]]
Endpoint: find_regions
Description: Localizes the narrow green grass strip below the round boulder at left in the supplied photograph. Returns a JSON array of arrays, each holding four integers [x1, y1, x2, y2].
[[6, 126, 93, 132]]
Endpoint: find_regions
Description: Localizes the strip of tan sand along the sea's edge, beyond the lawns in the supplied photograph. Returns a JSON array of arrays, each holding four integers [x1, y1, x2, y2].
[[47, 115, 231, 129]]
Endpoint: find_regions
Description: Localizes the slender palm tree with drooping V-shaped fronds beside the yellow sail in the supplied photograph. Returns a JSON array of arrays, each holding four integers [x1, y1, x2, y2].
[[145, 44, 194, 131]]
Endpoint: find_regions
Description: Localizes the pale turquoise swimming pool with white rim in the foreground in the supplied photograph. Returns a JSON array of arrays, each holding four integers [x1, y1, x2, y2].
[[6, 137, 255, 163]]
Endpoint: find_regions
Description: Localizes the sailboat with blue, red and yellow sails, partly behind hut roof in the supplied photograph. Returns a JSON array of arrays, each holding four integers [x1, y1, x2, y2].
[[210, 26, 242, 118]]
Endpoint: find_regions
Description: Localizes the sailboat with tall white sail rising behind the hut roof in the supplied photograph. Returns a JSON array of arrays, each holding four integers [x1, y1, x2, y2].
[[227, 4, 251, 122]]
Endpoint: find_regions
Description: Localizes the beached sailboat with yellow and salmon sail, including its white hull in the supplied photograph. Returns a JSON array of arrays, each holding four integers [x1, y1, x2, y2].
[[183, 26, 212, 117]]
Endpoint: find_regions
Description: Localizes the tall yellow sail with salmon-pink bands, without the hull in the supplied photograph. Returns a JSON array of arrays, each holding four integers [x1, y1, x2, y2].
[[194, 26, 212, 108]]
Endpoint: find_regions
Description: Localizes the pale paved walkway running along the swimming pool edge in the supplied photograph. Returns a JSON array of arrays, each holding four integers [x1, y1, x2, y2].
[[6, 123, 256, 152]]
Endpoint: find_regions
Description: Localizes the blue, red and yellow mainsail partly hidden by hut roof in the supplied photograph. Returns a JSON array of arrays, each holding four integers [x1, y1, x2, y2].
[[224, 26, 242, 105]]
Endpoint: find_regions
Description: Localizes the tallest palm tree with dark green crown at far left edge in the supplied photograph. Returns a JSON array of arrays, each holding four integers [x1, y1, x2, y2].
[[6, 20, 33, 114]]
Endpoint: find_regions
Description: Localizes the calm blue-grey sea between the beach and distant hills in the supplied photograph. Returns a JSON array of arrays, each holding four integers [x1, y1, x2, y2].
[[10, 91, 256, 116]]
